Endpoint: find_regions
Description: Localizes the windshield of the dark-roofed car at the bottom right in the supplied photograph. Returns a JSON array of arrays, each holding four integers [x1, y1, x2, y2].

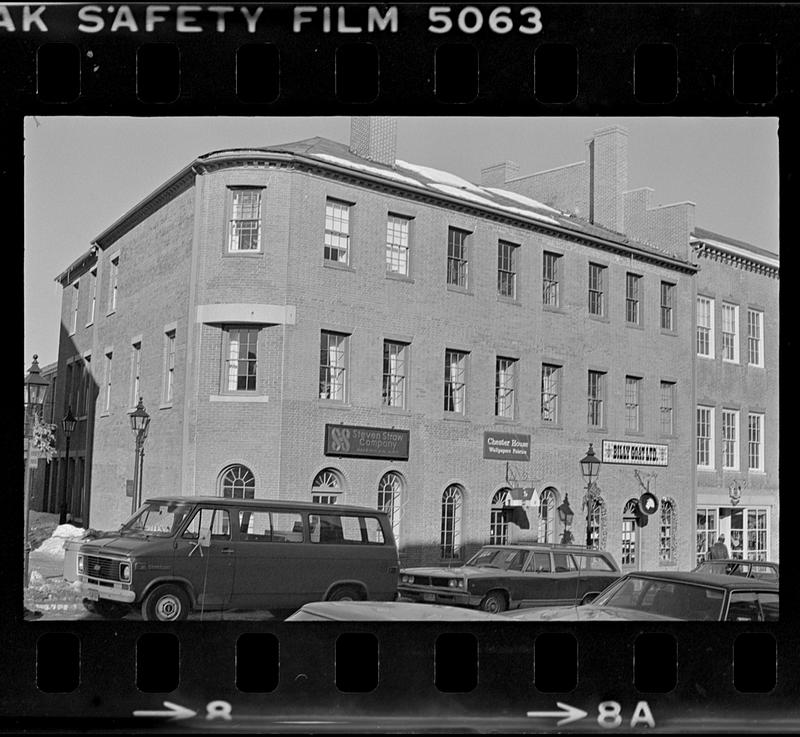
[[592, 576, 724, 620]]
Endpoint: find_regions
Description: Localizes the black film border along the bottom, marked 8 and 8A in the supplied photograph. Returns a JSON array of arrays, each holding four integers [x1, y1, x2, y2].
[[0, 623, 800, 731]]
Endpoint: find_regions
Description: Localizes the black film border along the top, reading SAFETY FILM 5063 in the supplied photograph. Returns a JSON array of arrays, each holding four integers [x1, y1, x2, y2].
[[0, 3, 800, 115]]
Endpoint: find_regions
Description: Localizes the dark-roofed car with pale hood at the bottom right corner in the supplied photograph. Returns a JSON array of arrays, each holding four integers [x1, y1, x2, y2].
[[504, 571, 778, 622]]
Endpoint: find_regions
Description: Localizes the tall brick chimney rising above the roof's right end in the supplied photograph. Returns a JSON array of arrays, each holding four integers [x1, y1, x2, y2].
[[586, 126, 628, 233]]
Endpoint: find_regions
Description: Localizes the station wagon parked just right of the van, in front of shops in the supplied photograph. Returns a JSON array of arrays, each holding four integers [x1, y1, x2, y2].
[[398, 543, 621, 613]]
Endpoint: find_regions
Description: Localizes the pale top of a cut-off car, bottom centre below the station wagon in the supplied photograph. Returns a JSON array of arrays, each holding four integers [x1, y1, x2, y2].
[[285, 601, 504, 622]]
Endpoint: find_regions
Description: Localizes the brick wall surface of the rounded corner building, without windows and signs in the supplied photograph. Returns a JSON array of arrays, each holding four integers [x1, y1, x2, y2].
[[42, 121, 777, 569]]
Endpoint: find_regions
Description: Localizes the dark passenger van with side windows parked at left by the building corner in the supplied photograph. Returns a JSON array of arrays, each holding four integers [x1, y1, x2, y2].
[[77, 496, 399, 622]]
